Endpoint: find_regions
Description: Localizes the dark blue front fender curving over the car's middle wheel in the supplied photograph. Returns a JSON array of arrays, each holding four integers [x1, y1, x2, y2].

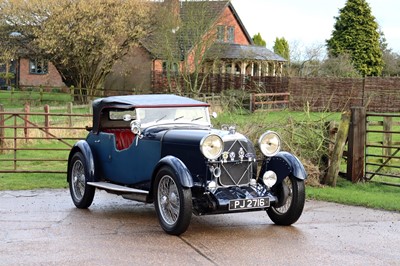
[[153, 155, 193, 188]]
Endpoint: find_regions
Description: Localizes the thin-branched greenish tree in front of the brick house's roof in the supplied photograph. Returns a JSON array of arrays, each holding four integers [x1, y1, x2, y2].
[[145, 1, 225, 94]]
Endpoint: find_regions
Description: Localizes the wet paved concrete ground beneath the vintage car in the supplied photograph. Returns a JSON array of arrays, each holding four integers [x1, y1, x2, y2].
[[0, 190, 400, 265]]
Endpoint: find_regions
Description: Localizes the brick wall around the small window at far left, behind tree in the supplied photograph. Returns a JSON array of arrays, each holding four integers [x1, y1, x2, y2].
[[19, 58, 65, 88]]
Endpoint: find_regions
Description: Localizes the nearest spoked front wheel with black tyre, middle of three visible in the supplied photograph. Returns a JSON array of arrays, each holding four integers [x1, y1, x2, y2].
[[154, 166, 192, 235]]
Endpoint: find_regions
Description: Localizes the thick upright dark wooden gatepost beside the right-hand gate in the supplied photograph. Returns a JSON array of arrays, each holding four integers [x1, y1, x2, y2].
[[347, 107, 366, 183]]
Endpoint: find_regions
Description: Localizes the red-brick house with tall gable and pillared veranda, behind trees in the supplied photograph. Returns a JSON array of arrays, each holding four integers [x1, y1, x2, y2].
[[104, 0, 286, 93]]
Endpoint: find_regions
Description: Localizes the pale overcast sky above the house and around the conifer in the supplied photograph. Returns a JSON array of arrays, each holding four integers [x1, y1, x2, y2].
[[231, 0, 400, 53]]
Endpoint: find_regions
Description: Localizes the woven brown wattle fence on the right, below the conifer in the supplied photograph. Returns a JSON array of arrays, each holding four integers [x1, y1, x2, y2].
[[288, 77, 400, 112]]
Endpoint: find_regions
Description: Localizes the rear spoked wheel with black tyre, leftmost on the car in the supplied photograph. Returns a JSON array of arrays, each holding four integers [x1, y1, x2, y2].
[[68, 152, 96, 209]]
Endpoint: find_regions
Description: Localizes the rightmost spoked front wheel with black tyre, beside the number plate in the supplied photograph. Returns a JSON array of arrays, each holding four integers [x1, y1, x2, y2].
[[267, 176, 305, 225]]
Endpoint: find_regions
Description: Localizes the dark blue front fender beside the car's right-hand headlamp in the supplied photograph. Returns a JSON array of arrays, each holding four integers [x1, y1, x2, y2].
[[259, 151, 307, 183]]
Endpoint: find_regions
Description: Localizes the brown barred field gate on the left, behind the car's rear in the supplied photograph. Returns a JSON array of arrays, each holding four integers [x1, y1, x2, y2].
[[0, 105, 92, 174]]
